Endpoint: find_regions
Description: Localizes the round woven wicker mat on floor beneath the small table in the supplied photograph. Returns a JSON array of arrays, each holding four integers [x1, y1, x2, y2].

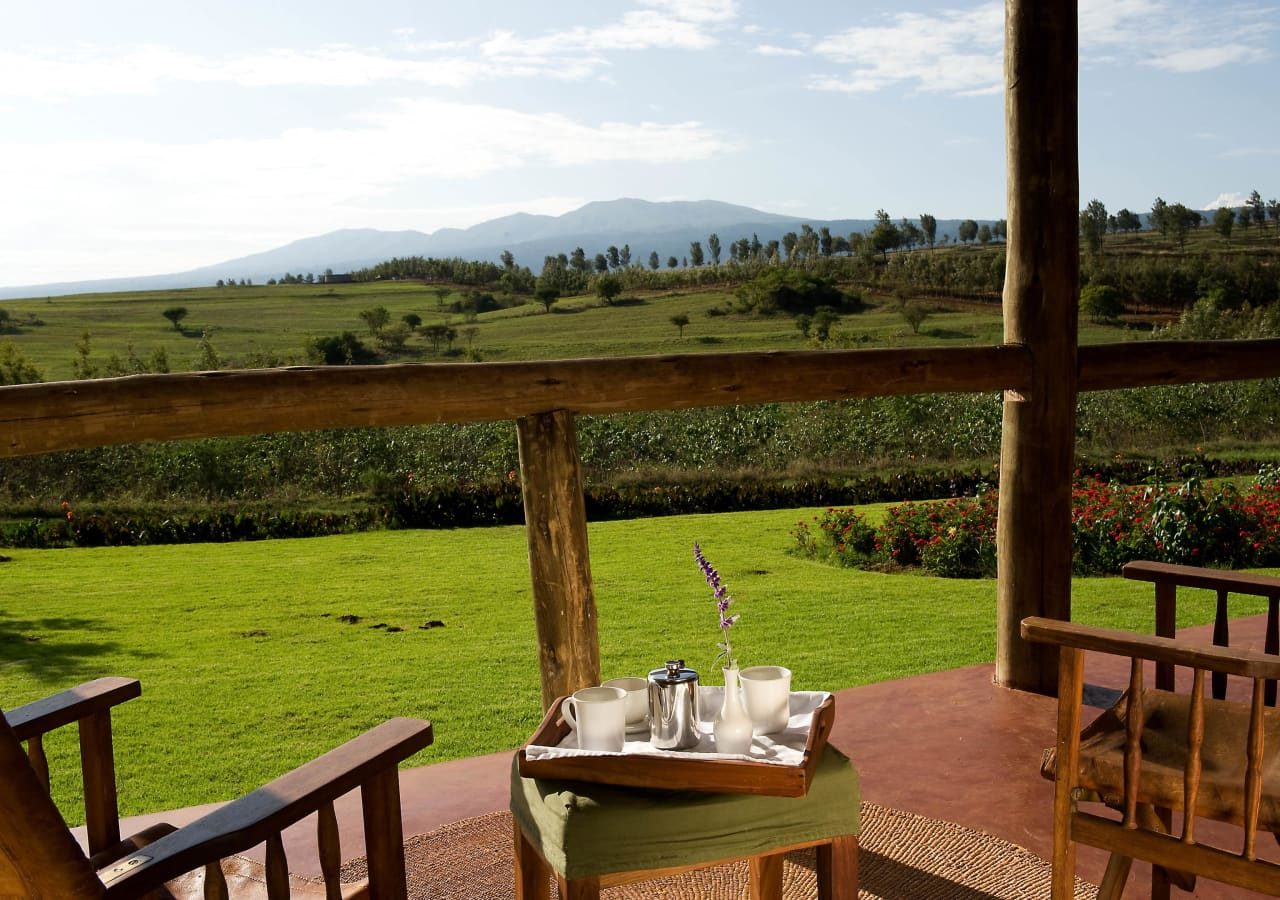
[[342, 803, 1096, 900]]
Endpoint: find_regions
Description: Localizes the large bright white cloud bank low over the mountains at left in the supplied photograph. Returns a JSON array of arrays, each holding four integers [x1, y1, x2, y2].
[[0, 100, 735, 283]]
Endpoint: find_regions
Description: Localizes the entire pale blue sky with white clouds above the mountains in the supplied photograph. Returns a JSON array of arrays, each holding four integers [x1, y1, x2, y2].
[[0, 0, 1280, 285]]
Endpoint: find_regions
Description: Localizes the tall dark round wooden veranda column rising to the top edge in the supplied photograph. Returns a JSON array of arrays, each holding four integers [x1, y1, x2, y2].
[[996, 0, 1080, 694]]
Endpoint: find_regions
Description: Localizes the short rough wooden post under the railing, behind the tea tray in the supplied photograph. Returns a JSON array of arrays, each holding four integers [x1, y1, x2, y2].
[[516, 410, 600, 709]]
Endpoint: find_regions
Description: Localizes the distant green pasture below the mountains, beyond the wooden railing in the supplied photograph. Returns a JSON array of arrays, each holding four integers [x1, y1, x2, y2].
[[0, 282, 1141, 380]]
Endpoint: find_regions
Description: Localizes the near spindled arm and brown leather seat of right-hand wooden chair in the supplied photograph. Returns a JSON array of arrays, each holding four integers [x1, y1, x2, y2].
[[1021, 618, 1280, 900]]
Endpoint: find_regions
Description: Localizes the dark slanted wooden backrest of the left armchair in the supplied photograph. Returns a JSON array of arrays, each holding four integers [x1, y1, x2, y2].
[[0, 716, 104, 900]]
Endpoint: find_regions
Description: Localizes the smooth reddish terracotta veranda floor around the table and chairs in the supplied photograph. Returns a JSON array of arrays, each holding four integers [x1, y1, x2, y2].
[[92, 616, 1276, 899]]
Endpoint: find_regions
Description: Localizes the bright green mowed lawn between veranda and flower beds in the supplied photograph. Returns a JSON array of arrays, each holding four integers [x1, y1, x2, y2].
[[0, 510, 1261, 821]]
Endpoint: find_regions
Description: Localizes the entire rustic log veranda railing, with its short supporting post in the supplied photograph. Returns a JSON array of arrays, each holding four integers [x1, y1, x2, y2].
[[0, 341, 1280, 703]]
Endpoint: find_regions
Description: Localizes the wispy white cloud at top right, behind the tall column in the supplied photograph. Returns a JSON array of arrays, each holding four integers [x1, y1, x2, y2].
[[810, 0, 1275, 95]]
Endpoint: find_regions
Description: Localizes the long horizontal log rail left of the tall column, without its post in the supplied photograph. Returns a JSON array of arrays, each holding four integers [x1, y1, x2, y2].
[[0, 346, 1030, 457]]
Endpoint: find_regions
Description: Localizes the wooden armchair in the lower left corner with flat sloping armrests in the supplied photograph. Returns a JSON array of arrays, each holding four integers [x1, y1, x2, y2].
[[0, 679, 431, 900]]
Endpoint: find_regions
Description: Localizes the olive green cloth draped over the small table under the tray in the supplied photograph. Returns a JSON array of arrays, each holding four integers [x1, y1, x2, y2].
[[511, 746, 860, 878]]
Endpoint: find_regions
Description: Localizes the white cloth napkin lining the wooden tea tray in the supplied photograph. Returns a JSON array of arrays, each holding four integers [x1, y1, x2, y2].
[[525, 685, 831, 766]]
